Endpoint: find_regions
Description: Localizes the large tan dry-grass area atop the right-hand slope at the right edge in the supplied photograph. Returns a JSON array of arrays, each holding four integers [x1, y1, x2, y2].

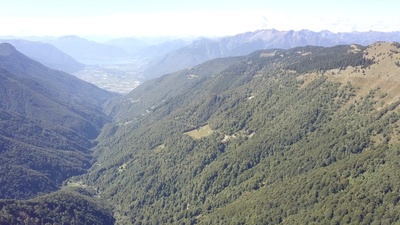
[[297, 42, 400, 110]]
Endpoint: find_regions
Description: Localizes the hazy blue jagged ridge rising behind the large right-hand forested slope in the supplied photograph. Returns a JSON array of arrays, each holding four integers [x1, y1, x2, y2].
[[144, 29, 400, 78]]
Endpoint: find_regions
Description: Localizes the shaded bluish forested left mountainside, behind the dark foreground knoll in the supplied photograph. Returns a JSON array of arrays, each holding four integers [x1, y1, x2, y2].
[[0, 44, 113, 199]]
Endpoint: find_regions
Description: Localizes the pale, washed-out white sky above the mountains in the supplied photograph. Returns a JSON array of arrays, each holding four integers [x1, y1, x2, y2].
[[0, 0, 400, 38]]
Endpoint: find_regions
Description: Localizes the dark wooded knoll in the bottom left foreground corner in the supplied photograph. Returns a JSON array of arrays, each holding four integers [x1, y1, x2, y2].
[[0, 191, 115, 225]]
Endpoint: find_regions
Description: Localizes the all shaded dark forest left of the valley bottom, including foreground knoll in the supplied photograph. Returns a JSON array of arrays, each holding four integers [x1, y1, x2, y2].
[[0, 44, 115, 225]]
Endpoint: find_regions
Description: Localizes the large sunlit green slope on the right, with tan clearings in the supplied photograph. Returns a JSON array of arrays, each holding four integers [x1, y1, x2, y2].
[[72, 43, 400, 224]]
